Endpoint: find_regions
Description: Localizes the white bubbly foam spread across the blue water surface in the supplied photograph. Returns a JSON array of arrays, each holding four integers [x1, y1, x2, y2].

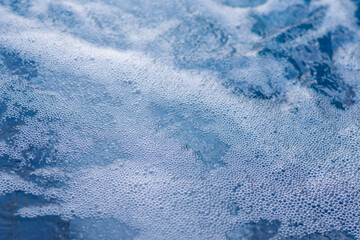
[[0, 1, 360, 239]]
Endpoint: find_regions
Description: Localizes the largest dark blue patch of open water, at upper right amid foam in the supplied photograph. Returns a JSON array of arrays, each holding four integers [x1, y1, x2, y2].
[[248, 5, 355, 110]]
